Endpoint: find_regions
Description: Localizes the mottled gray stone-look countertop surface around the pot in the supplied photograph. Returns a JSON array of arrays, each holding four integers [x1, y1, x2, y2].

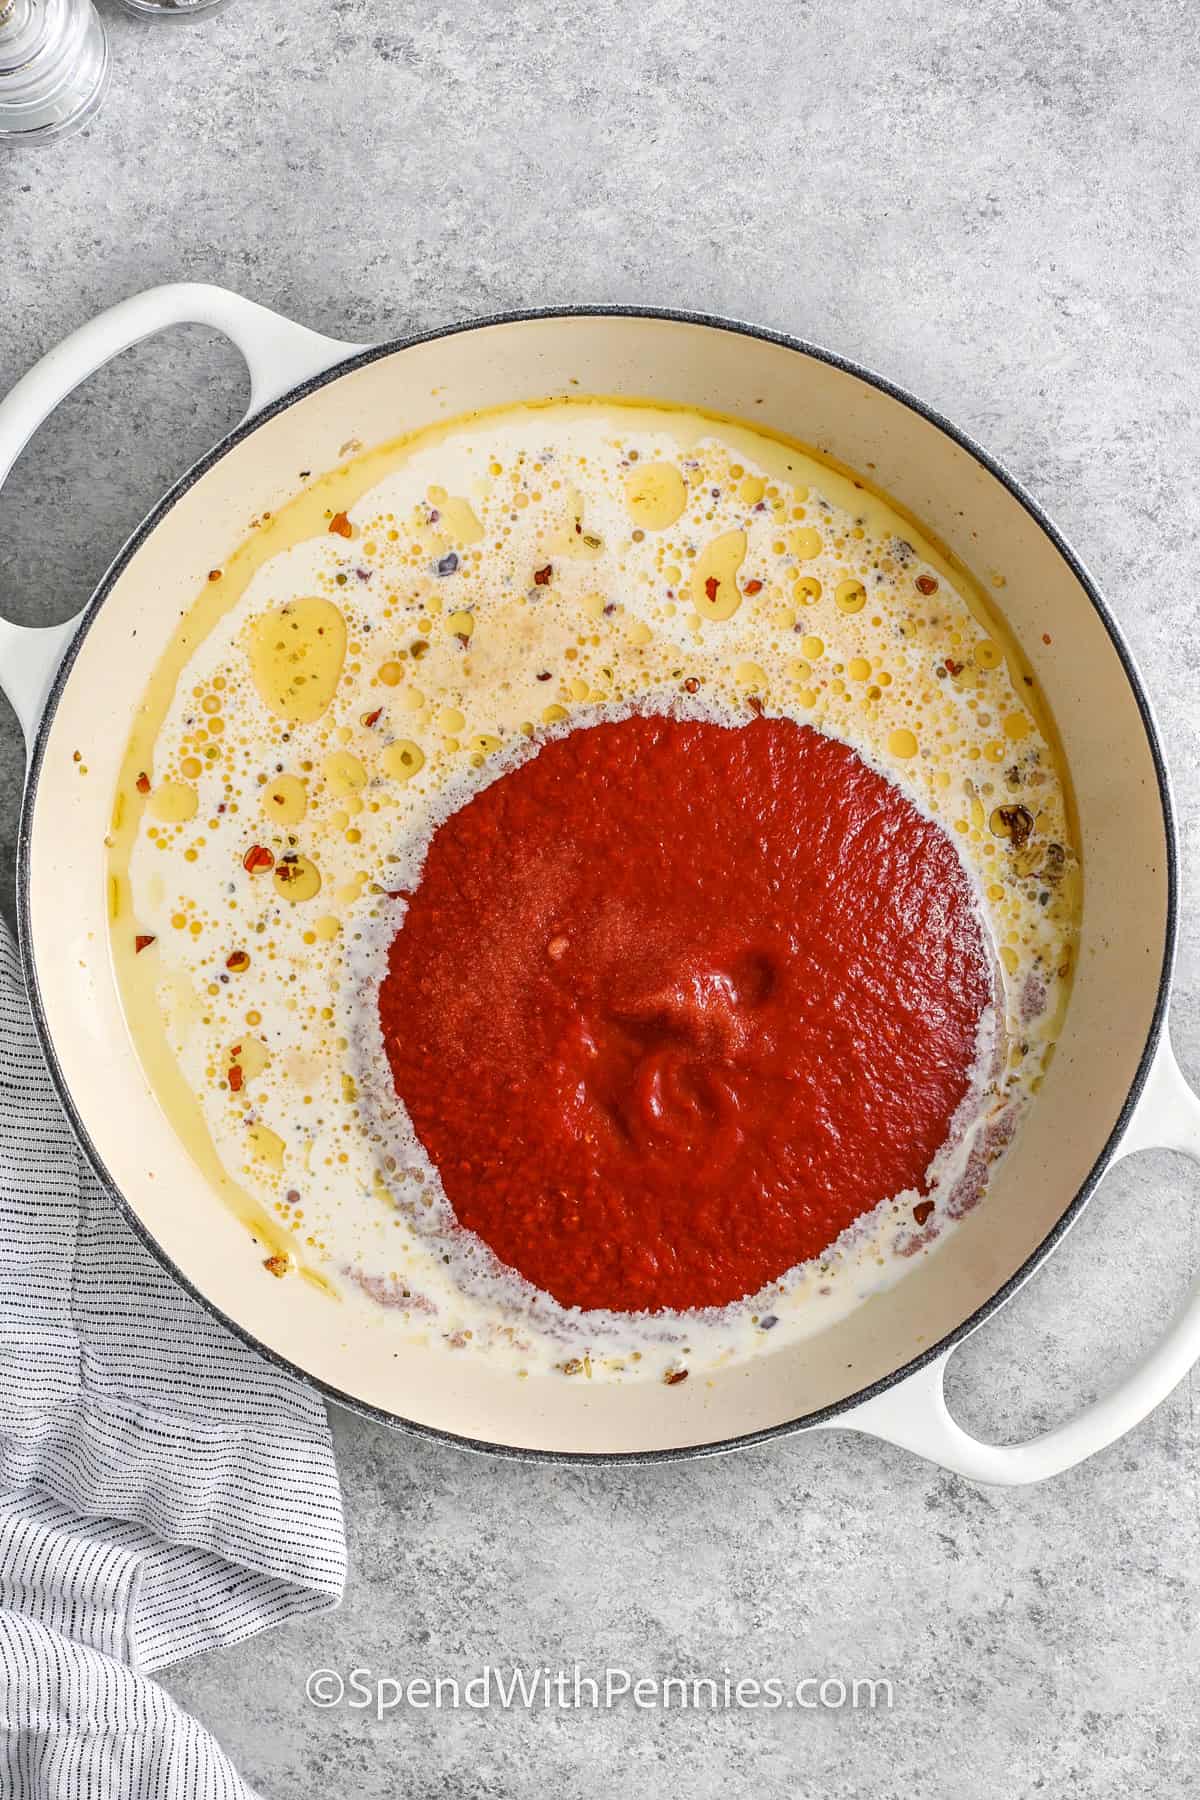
[[0, 0, 1200, 1800]]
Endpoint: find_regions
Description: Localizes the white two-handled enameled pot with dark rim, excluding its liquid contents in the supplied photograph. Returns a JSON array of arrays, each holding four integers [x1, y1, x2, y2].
[[0, 284, 1200, 1483]]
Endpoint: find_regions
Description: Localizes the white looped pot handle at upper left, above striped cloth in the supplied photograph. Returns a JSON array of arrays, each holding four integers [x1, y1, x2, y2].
[[0, 281, 363, 745]]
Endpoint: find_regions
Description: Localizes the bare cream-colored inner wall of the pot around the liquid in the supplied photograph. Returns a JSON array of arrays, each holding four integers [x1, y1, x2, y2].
[[29, 317, 1168, 1453]]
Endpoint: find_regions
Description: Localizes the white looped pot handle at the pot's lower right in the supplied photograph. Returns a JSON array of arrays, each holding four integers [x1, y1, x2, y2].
[[829, 1030, 1200, 1487]]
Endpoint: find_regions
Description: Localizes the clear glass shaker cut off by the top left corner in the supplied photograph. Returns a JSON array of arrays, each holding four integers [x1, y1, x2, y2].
[[0, 0, 108, 149]]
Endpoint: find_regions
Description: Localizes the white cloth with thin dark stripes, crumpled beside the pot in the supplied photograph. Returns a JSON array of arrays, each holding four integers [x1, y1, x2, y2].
[[0, 925, 345, 1800]]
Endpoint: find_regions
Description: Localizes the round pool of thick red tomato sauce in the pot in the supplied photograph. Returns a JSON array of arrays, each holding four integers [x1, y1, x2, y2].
[[380, 716, 991, 1312]]
